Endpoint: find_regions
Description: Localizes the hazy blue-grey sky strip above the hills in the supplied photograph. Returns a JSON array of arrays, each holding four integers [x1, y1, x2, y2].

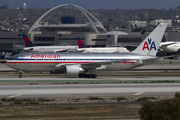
[[0, 0, 180, 10]]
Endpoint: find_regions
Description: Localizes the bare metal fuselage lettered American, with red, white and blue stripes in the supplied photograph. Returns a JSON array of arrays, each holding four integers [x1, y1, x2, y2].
[[6, 53, 157, 71]]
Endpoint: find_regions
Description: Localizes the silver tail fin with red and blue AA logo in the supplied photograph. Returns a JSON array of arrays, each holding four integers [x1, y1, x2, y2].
[[132, 23, 167, 56]]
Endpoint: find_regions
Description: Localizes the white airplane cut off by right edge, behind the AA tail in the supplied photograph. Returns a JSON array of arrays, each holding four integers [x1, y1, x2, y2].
[[159, 36, 180, 53]]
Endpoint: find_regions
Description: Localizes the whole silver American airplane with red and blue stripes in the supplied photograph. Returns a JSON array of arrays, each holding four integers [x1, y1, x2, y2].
[[6, 23, 169, 78]]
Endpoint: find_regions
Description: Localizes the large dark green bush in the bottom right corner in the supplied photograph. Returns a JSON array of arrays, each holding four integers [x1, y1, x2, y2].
[[139, 99, 180, 120]]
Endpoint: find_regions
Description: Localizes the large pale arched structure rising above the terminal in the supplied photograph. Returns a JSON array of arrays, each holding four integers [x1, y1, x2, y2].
[[29, 4, 107, 34]]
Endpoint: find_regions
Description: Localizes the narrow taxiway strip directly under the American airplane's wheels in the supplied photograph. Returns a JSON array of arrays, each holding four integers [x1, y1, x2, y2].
[[0, 73, 180, 84]]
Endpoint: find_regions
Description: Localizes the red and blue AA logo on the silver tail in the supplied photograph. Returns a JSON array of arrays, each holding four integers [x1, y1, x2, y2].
[[142, 38, 156, 50]]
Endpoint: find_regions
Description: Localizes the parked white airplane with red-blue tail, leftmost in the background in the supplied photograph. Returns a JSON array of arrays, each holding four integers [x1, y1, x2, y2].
[[22, 34, 78, 52]]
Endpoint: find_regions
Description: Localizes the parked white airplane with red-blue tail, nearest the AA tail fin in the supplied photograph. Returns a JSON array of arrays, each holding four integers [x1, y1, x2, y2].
[[76, 37, 129, 53]]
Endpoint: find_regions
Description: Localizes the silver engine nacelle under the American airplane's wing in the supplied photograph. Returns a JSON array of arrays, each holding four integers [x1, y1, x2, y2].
[[65, 65, 83, 75]]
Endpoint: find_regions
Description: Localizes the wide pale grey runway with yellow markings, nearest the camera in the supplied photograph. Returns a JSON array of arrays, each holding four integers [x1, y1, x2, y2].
[[0, 83, 180, 98]]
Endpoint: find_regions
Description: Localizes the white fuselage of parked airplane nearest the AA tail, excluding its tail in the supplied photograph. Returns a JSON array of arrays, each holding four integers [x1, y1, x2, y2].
[[76, 47, 129, 53]]
